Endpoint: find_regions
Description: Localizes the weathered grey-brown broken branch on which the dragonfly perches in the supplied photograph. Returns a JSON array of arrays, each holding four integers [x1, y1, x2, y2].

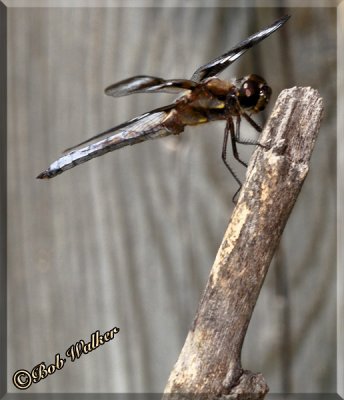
[[164, 88, 323, 399]]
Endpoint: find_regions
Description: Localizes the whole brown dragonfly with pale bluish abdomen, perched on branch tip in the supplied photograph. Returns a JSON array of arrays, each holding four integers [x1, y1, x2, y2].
[[37, 15, 290, 198]]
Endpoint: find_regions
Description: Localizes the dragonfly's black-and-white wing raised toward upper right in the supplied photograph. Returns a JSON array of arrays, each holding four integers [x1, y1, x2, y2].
[[191, 15, 290, 82]]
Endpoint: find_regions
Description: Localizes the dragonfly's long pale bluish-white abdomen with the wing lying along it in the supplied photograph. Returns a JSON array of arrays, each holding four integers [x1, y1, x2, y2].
[[37, 104, 180, 179]]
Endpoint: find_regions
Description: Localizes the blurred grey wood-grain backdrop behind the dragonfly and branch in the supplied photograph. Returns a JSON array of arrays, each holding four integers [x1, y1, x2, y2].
[[8, 1, 336, 393]]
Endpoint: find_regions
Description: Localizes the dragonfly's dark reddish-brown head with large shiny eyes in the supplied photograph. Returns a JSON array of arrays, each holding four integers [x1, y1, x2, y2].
[[238, 74, 272, 113]]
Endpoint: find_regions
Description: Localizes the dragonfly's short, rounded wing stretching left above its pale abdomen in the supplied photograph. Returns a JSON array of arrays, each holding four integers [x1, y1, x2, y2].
[[105, 75, 197, 97]]
